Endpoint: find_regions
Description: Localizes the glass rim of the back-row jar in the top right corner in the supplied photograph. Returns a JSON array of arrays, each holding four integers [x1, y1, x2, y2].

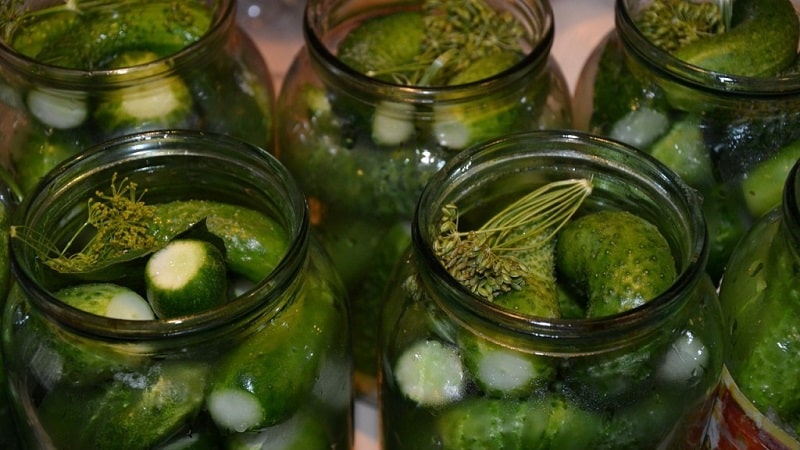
[[614, 0, 800, 97]]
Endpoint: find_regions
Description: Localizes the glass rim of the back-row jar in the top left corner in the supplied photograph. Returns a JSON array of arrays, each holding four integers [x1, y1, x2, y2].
[[0, 0, 236, 89]]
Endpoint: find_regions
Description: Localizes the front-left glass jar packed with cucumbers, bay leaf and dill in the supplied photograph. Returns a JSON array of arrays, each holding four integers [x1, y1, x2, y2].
[[3, 131, 352, 449]]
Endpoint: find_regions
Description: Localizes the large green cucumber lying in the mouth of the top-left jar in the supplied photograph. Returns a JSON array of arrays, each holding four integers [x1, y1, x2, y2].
[[24, 0, 213, 70]]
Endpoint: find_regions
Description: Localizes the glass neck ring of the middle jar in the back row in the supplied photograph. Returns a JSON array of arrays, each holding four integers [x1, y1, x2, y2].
[[303, 0, 555, 104]]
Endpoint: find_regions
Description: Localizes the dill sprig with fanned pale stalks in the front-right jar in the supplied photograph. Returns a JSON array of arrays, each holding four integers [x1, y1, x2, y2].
[[433, 179, 592, 301]]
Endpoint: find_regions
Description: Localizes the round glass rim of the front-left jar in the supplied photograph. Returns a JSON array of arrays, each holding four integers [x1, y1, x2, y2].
[[11, 130, 310, 339]]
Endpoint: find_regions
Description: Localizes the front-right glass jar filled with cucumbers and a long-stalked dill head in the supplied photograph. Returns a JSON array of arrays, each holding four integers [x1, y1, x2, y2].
[[379, 132, 723, 450]]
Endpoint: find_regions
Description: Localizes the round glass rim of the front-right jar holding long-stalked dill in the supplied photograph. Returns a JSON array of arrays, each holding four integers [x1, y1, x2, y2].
[[412, 131, 708, 348]]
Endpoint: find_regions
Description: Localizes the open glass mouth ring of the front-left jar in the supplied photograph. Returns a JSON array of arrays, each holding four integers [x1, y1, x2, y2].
[[11, 130, 309, 340]]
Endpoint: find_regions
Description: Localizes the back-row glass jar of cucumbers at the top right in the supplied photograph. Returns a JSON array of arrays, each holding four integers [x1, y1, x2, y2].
[[573, 0, 800, 280]]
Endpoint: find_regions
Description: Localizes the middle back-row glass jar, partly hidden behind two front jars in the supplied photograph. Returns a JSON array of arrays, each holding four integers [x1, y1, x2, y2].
[[277, 0, 571, 393]]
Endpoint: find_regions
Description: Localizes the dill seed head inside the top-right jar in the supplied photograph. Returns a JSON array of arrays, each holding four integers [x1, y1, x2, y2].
[[636, 0, 730, 52]]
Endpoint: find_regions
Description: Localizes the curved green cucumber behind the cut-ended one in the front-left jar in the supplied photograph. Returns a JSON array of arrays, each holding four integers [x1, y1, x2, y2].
[[151, 200, 289, 282]]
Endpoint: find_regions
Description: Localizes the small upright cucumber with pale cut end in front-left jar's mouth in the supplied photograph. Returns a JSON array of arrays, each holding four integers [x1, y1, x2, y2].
[[144, 239, 228, 319]]
